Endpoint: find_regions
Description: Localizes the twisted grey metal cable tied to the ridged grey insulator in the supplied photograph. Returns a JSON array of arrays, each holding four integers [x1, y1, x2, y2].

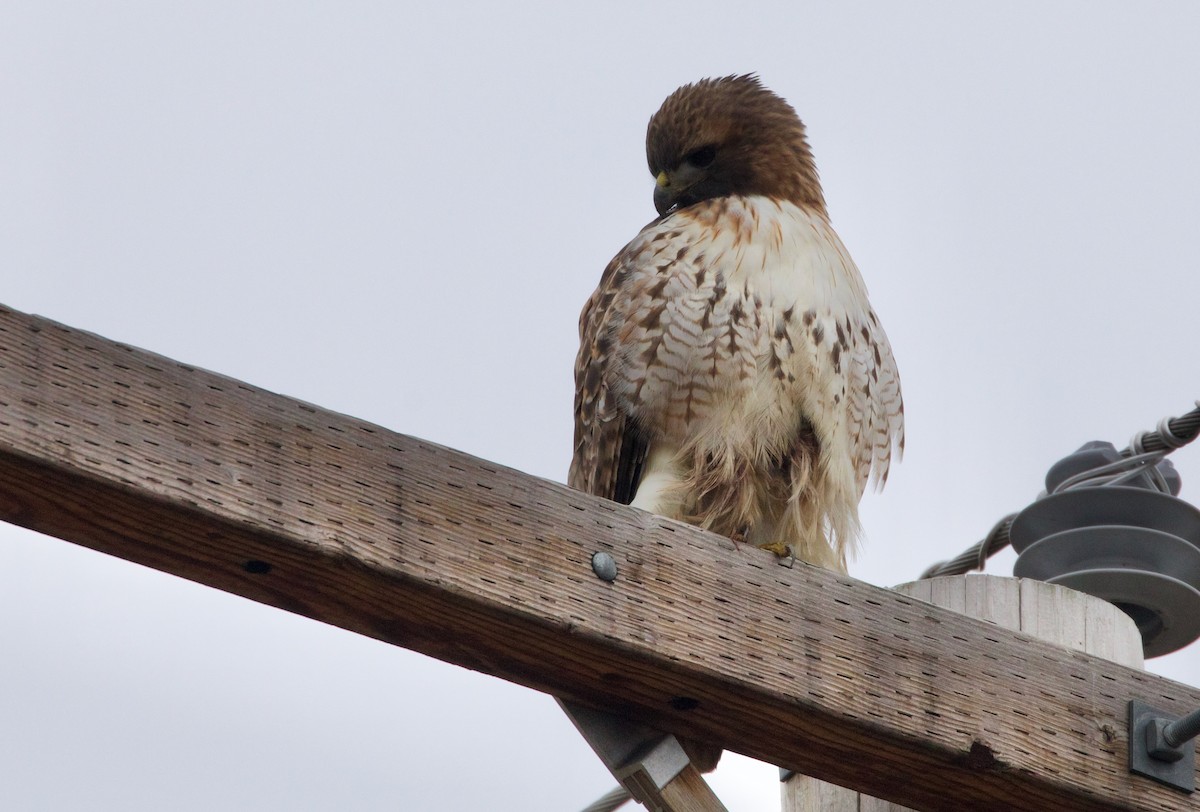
[[920, 401, 1200, 578]]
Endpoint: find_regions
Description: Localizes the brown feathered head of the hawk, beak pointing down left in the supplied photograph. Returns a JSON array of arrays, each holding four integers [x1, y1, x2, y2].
[[646, 74, 826, 215]]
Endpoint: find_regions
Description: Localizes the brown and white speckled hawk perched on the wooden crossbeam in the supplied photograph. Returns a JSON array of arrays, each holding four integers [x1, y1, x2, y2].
[[568, 74, 904, 572]]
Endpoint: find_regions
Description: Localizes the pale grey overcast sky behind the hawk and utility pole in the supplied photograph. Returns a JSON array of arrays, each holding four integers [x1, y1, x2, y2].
[[0, 0, 1200, 812]]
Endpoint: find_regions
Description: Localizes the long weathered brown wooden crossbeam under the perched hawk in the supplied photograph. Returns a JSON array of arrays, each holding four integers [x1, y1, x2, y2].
[[0, 309, 1200, 811]]
